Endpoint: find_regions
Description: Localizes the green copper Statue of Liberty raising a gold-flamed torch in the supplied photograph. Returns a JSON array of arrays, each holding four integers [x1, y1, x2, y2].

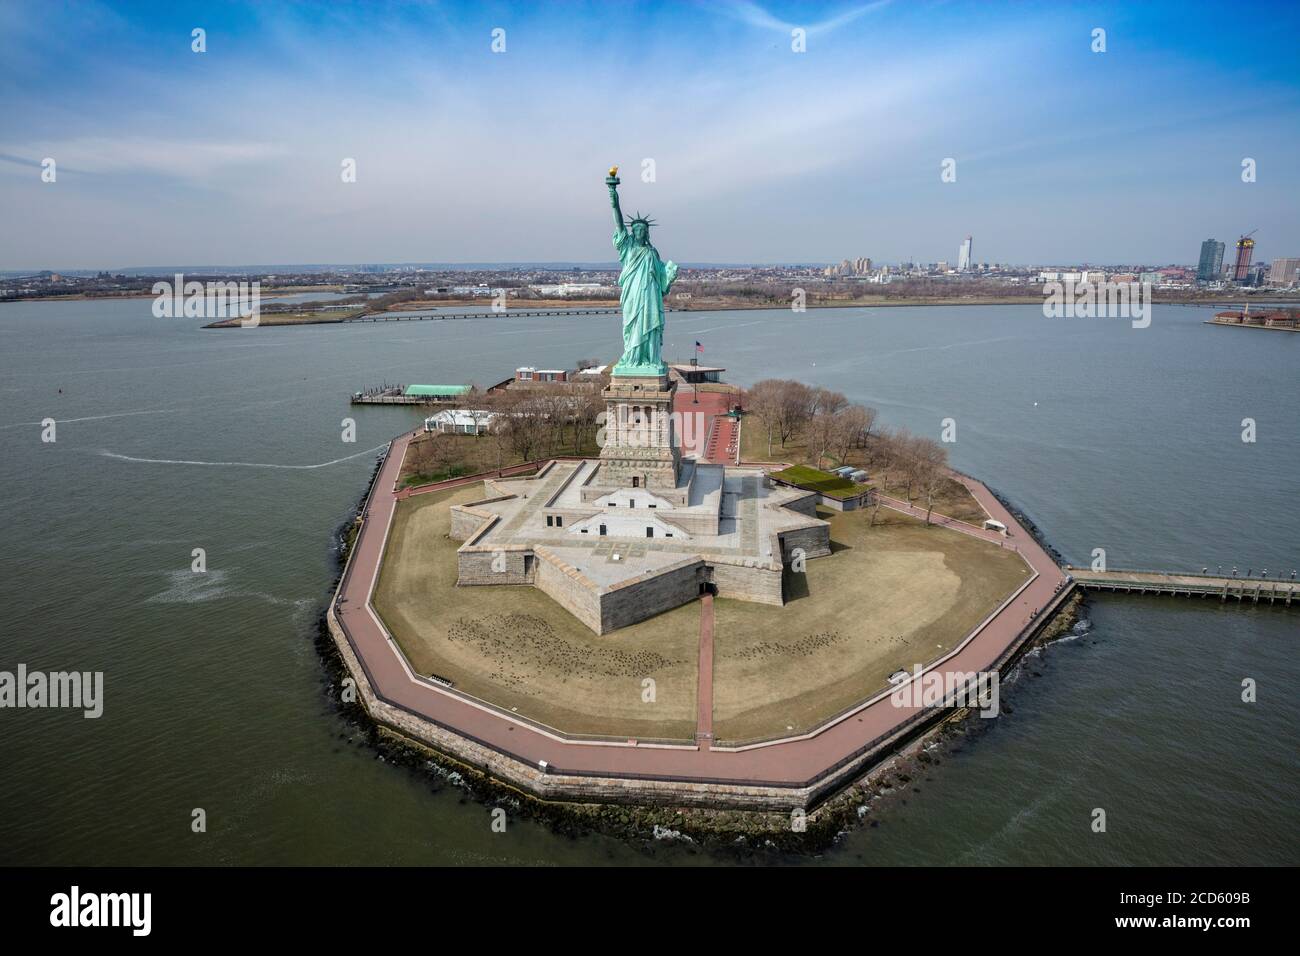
[[605, 166, 677, 376]]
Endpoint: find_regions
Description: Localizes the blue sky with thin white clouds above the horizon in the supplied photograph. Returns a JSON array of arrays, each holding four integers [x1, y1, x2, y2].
[[0, 0, 1300, 271]]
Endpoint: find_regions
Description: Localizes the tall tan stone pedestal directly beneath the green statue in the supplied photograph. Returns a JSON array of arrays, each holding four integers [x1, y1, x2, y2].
[[599, 375, 681, 489]]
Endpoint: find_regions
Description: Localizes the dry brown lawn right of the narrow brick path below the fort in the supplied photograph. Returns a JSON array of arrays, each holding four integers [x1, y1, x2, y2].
[[714, 509, 1030, 743]]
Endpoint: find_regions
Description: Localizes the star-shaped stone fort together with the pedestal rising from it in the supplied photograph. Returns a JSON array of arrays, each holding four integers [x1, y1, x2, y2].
[[451, 373, 831, 633]]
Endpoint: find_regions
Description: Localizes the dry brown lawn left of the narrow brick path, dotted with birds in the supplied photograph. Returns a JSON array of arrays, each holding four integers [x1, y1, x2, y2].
[[374, 483, 699, 740]]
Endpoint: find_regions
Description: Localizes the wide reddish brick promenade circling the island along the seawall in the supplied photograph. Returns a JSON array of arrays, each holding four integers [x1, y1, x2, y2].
[[337, 434, 1063, 787]]
